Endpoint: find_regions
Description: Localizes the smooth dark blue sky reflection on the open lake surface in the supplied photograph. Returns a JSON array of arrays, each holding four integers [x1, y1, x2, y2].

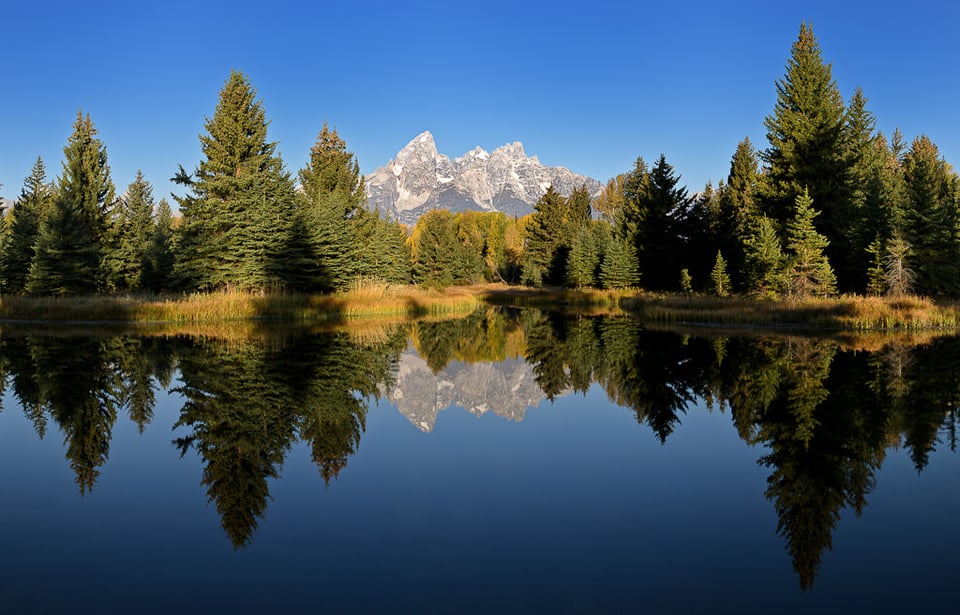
[[0, 332, 960, 612]]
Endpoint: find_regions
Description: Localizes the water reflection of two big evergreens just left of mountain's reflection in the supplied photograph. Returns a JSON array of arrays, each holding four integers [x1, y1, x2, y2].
[[177, 332, 405, 548]]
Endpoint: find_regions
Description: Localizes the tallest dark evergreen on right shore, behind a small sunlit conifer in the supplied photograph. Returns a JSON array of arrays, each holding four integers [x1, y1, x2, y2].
[[763, 23, 848, 274]]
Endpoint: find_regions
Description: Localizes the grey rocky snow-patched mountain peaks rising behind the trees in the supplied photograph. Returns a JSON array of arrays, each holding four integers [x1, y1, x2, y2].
[[365, 131, 603, 224]]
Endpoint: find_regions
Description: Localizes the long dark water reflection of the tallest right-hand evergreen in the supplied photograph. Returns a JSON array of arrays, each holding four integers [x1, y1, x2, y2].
[[755, 339, 883, 588]]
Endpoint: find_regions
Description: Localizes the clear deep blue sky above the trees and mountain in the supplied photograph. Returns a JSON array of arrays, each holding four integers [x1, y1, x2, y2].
[[0, 0, 960, 205]]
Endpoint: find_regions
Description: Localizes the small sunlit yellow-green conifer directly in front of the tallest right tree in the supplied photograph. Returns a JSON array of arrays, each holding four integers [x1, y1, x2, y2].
[[787, 191, 837, 297]]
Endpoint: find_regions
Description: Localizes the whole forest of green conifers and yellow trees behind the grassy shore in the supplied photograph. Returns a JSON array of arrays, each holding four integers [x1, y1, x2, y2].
[[0, 24, 960, 298]]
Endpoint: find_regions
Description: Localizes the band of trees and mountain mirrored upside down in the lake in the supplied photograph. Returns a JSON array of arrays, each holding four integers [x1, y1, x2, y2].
[[0, 309, 960, 604]]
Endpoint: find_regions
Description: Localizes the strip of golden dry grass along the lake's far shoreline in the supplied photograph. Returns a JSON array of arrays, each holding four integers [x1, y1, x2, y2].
[[0, 282, 960, 331]]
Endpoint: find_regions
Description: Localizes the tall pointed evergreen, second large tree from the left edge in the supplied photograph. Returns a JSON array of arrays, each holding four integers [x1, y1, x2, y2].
[[25, 112, 114, 295]]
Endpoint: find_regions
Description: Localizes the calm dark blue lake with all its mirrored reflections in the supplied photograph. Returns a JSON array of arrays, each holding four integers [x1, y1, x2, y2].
[[0, 310, 960, 613]]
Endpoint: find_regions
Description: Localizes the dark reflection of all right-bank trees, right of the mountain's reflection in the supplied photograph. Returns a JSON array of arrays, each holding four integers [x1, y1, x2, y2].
[[510, 313, 960, 588]]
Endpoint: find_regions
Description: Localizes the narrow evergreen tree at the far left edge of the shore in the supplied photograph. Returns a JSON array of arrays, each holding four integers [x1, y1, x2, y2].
[[0, 158, 54, 294]]
